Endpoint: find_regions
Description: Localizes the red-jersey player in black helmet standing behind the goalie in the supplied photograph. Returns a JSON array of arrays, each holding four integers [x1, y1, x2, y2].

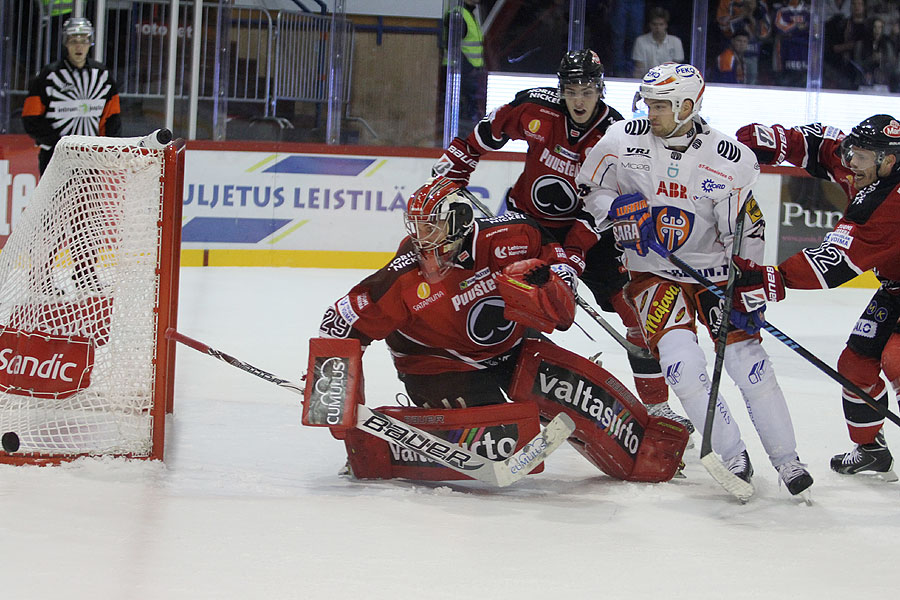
[[432, 50, 693, 431]]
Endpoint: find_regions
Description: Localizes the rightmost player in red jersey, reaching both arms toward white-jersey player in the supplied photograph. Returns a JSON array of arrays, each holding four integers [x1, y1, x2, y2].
[[734, 114, 900, 480]]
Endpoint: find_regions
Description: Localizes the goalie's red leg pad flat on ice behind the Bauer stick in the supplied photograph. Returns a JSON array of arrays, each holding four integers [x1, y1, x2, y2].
[[344, 402, 544, 481]]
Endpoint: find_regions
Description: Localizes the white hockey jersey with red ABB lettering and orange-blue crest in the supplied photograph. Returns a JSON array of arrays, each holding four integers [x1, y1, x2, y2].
[[575, 118, 765, 283]]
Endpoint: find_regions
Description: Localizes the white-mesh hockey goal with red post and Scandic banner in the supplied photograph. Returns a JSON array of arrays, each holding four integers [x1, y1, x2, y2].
[[0, 134, 184, 463]]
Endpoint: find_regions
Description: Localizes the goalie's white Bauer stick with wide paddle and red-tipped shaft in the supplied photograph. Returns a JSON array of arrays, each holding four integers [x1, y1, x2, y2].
[[166, 328, 575, 487]]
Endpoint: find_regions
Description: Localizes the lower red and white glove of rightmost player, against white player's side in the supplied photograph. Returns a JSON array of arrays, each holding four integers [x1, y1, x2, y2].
[[731, 256, 784, 335]]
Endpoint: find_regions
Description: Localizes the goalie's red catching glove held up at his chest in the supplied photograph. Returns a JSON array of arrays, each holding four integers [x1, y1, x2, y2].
[[497, 258, 575, 333]]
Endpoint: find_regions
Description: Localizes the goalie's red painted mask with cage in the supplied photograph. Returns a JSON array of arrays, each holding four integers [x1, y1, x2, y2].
[[404, 177, 475, 283]]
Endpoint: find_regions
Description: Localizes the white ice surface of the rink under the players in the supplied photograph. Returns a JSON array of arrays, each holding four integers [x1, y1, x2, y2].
[[0, 268, 900, 600]]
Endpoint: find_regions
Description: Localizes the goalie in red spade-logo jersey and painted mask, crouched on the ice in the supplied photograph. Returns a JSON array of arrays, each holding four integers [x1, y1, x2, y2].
[[319, 177, 689, 481]]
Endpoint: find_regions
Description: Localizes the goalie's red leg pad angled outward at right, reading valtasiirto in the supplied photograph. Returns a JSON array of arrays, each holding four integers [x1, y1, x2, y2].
[[510, 339, 689, 481]]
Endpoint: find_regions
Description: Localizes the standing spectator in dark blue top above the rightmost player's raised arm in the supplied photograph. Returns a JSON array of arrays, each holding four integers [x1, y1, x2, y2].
[[772, 0, 809, 88]]
